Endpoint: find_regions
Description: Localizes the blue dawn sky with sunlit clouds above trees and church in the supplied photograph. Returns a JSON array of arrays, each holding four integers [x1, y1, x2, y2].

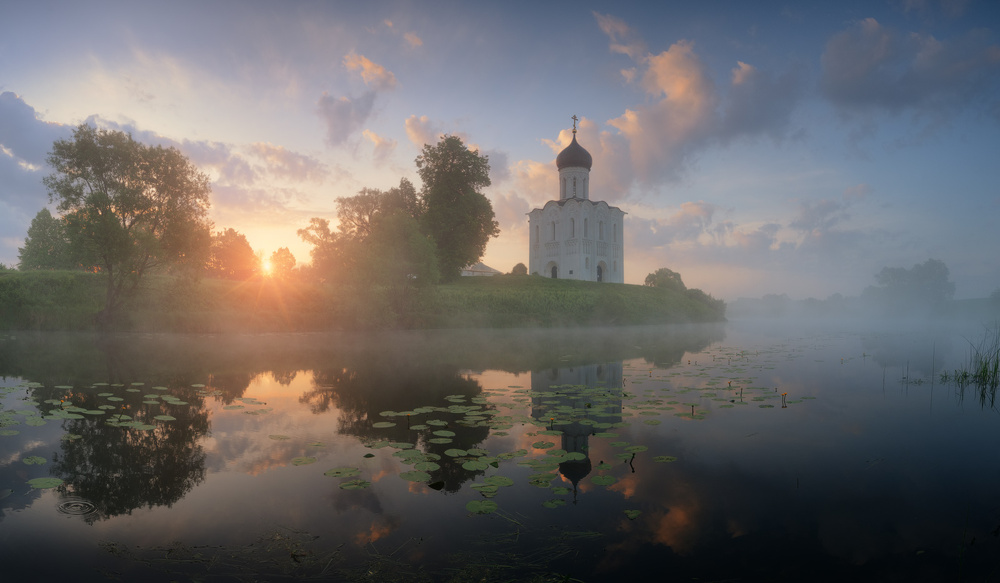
[[0, 0, 1000, 300]]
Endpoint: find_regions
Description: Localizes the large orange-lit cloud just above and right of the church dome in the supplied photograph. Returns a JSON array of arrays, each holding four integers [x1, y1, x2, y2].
[[585, 13, 804, 190]]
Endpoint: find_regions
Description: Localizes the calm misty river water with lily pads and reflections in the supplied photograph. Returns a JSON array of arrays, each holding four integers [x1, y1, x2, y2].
[[0, 322, 1000, 581]]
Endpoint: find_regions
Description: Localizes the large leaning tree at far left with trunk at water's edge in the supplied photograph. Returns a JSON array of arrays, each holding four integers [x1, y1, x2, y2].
[[43, 124, 211, 327]]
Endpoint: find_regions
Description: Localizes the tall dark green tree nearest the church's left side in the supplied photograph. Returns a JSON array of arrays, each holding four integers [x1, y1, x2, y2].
[[416, 136, 500, 278]]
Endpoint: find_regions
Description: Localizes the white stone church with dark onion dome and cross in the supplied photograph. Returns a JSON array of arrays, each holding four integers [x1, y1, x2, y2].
[[528, 115, 625, 283]]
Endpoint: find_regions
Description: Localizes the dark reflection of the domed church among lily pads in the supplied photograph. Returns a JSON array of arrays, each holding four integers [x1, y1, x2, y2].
[[531, 360, 623, 503]]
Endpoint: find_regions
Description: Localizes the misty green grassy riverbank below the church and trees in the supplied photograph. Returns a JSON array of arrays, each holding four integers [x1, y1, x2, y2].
[[0, 271, 725, 332]]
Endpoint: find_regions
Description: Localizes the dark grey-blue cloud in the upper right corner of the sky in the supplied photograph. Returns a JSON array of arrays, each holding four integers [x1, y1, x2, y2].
[[820, 18, 1000, 115]]
